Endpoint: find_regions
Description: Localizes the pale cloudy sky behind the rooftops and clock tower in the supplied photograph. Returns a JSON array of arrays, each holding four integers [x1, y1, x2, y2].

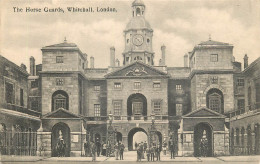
[[0, 0, 260, 68]]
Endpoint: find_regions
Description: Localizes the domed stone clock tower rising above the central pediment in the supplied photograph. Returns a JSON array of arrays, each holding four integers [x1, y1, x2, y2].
[[123, 0, 154, 65]]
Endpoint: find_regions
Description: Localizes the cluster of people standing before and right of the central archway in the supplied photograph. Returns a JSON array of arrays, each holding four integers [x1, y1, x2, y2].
[[135, 142, 175, 161]]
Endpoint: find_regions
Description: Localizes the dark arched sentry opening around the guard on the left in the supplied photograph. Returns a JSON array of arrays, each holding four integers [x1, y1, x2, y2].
[[51, 122, 70, 157]]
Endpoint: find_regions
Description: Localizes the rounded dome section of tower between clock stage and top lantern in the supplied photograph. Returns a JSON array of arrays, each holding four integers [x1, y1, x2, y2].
[[126, 17, 152, 31]]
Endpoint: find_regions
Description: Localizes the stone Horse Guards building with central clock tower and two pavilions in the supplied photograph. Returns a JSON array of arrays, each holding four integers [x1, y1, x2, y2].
[[0, 0, 260, 156]]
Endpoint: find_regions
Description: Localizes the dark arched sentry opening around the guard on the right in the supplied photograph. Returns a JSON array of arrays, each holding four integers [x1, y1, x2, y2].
[[194, 122, 213, 157]]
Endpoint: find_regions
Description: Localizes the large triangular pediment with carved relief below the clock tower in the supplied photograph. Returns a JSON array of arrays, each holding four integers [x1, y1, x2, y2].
[[105, 62, 168, 78]]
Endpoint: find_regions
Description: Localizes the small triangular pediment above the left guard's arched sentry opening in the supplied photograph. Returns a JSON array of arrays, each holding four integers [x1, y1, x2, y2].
[[43, 108, 80, 118]]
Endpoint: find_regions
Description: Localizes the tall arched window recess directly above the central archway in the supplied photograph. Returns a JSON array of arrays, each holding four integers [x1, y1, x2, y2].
[[127, 93, 147, 118]]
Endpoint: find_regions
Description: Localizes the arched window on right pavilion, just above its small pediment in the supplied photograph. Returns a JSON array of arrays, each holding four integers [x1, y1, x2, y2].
[[207, 88, 224, 113]]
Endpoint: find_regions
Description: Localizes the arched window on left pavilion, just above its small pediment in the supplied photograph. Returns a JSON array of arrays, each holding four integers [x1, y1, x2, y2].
[[52, 90, 69, 111]]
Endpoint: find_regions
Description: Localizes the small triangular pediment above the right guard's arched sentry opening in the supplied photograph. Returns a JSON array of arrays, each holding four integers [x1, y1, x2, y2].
[[183, 108, 225, 118]]
